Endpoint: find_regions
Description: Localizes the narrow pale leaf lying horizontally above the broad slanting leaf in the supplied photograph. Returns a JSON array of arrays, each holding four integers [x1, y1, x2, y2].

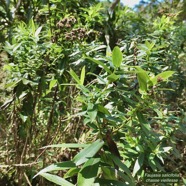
[[40, 143, 89, 149]]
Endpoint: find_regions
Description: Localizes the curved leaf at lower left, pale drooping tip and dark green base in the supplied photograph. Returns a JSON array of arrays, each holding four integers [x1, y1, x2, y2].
[[34, 161, 76, 178]]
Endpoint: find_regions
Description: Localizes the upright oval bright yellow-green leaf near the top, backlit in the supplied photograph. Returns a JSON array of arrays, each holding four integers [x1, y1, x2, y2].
[[112, 46, 123, 68]]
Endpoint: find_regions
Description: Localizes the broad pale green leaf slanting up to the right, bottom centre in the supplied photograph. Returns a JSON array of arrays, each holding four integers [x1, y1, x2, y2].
[[73, 139, 104, 166]]
